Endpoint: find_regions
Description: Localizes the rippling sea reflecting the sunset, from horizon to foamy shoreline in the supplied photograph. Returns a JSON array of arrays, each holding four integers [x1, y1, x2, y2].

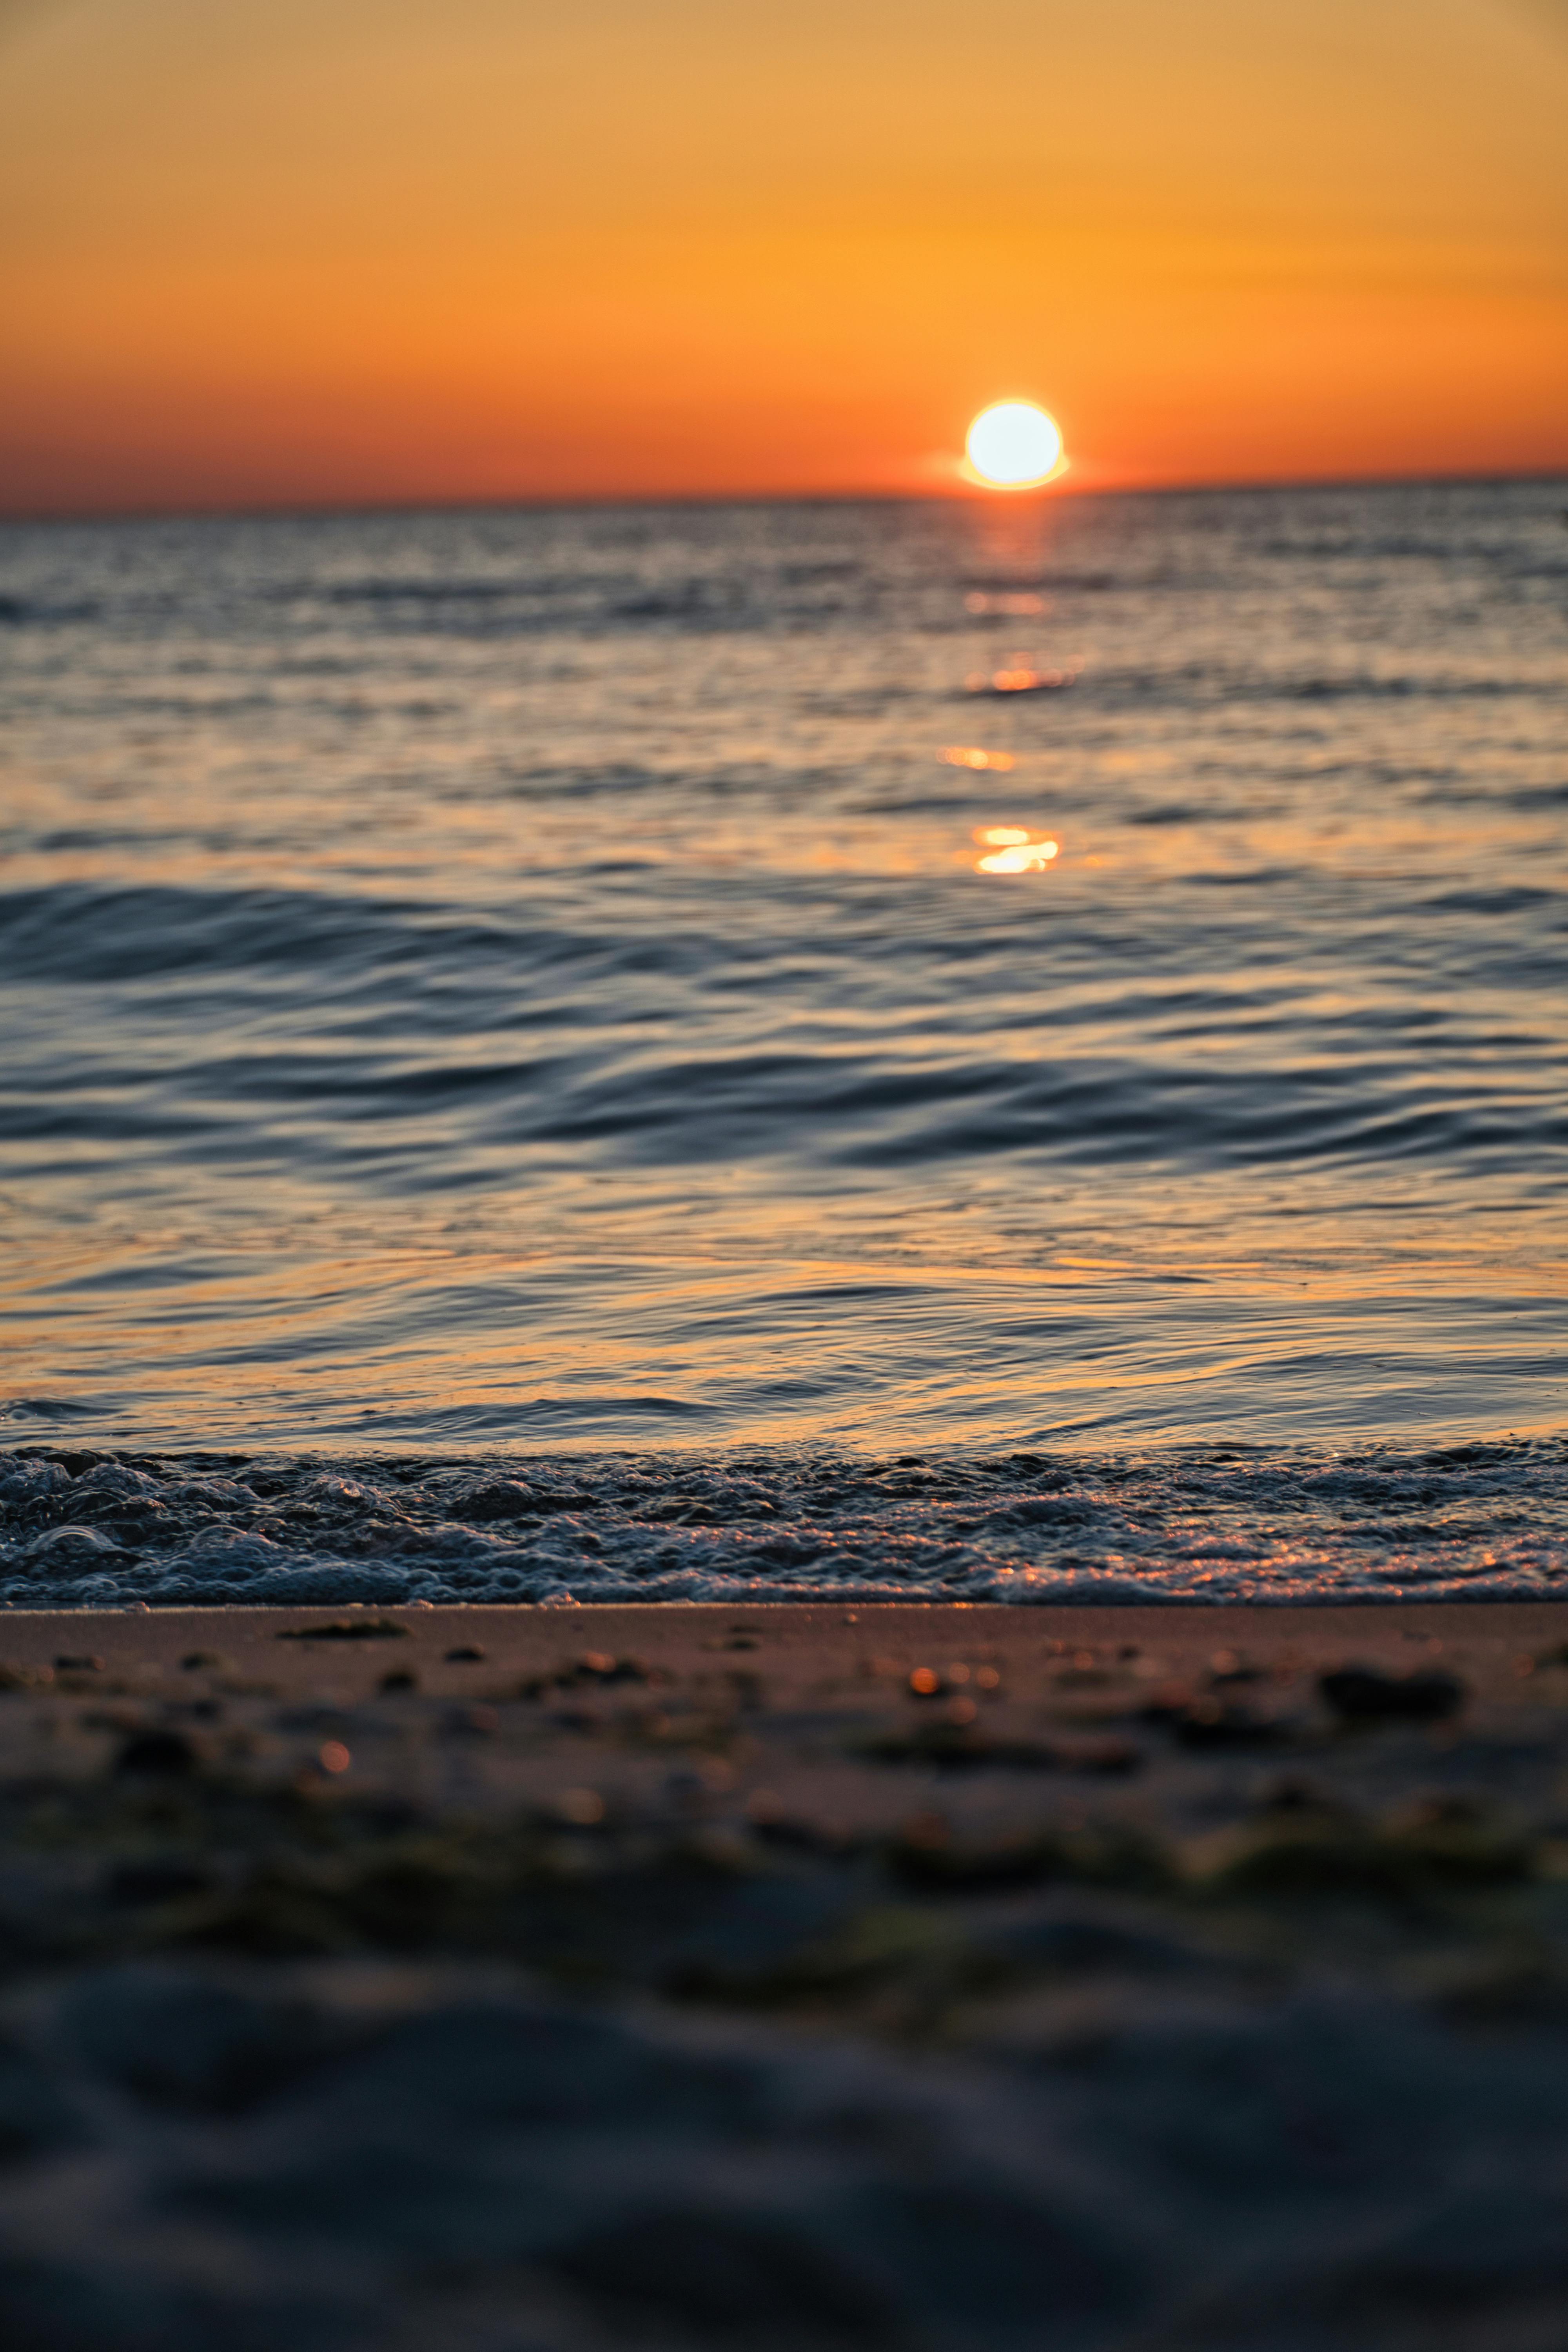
[[0, 482, 1568, 1602]]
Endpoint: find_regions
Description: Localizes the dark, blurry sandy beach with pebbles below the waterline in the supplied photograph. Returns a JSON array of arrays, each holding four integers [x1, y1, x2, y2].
[[0, 1604, 1568, 2352]]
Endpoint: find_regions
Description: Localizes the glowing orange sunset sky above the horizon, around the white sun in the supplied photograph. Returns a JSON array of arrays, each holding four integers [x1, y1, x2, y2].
[[0, 0, 1568, 515]]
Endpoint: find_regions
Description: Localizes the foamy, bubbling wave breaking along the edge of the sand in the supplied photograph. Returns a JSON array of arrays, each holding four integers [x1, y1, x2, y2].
[[0, 1439, 1568, 1609]]
